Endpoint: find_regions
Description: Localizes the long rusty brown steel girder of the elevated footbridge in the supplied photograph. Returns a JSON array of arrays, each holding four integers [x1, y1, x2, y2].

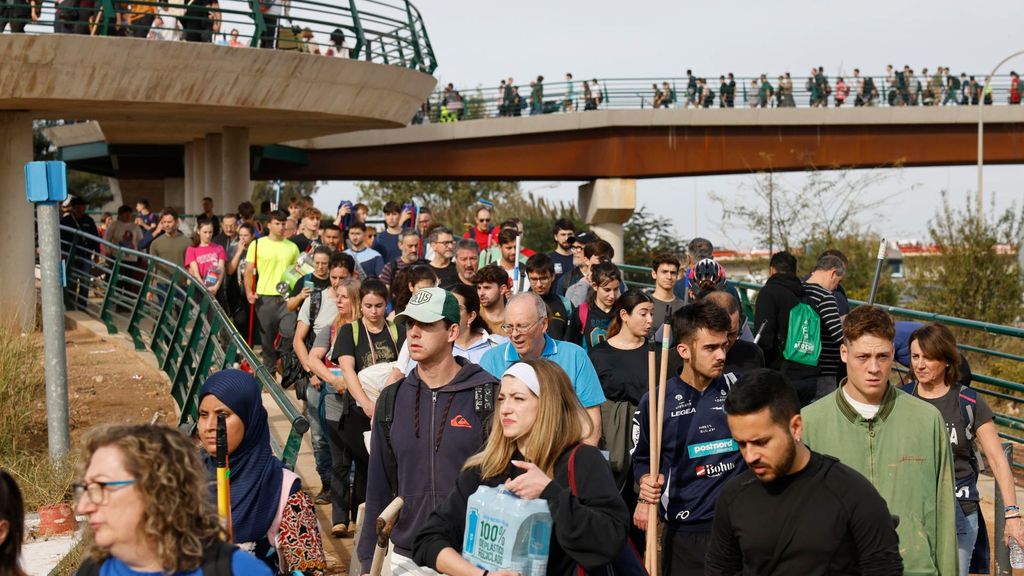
[[266, 120, 1024, 180]]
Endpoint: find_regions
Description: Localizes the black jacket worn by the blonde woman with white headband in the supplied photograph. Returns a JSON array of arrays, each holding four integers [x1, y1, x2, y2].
[[413, 446, 630, 576]]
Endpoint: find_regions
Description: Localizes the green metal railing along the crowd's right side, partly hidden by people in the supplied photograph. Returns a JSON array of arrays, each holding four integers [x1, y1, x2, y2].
[[620, 264, 1024, 469]]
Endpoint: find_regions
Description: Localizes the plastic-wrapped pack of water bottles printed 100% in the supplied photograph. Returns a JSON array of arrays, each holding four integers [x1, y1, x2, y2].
[[462, 484, 551, 576]]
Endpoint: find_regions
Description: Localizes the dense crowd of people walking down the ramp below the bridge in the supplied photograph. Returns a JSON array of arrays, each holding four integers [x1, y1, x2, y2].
[[28, 199, 1024, 576]]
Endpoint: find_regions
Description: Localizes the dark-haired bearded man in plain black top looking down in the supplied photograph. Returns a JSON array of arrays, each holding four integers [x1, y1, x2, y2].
[[698, 369, 903, 576]]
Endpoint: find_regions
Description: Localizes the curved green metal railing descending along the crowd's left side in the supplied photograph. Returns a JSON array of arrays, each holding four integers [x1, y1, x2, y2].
[[60, 227, 309, 468]]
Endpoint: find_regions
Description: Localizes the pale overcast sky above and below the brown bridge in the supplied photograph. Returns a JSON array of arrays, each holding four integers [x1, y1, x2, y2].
[[316, 0, 1024, 249]]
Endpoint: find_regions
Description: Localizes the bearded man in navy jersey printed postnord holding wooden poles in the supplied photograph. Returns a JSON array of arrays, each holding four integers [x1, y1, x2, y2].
[[633, 299, 745, 576]]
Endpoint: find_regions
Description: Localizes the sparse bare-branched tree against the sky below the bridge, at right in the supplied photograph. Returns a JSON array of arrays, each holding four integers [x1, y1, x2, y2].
[[711, 166, 913, 251]]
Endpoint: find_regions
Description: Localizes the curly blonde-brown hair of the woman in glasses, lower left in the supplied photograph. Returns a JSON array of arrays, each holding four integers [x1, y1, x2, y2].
[[79, 424, 223, 573]]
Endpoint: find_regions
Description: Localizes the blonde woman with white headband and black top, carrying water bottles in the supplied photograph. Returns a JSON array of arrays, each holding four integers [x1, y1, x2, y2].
[[413, 360, 629, 576]]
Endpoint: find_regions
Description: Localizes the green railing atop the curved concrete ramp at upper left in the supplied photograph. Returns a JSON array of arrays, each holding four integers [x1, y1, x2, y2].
[[5, 0, 437, 74]]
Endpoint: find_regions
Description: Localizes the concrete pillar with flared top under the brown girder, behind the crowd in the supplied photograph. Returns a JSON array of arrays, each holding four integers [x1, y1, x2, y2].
[[578, 178, 637, 264]]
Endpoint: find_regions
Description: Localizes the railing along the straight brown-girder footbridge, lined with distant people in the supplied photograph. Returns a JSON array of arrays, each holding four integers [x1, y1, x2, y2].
[[427, 74, 1024, 122]]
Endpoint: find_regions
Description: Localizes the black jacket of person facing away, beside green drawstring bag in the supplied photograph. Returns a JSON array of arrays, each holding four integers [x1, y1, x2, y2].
[[754, 273, 804, 370]]
